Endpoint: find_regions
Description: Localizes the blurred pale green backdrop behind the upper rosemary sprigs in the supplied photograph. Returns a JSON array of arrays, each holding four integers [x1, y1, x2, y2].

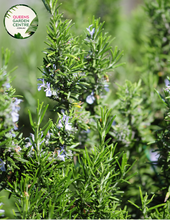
[[0, 0, 146, 136]]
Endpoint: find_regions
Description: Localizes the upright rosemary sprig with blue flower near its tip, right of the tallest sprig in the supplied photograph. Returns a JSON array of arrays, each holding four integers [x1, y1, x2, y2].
[[82, 18, 122, 108]]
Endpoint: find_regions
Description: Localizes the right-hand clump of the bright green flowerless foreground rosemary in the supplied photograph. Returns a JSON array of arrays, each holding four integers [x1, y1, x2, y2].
[[69, 114, 131, 219]]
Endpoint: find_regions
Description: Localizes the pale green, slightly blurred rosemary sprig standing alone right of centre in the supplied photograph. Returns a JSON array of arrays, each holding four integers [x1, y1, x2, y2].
[[111, 80, 153, 152]]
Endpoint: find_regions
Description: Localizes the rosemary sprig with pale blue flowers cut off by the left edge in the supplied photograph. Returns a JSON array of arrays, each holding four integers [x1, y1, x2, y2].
[[0, 48, 21, 182]]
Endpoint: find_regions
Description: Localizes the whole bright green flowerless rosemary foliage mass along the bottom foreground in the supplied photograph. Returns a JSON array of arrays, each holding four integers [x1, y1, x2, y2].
[[0, 100, 131, 219]]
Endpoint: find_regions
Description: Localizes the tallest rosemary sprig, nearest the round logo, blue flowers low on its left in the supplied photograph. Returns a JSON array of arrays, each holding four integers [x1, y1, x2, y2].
[[38, 4, 88, 110]]
